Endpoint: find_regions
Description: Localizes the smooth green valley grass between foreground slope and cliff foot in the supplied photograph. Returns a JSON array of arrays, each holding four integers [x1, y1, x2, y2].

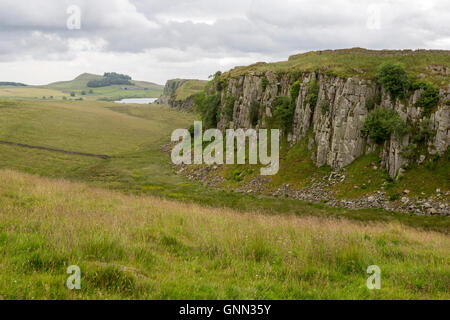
[[0, 97, 449, 232]]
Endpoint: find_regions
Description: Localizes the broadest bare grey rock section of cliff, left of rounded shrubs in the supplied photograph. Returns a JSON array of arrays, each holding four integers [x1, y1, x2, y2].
[[293, 75, 375, 168]]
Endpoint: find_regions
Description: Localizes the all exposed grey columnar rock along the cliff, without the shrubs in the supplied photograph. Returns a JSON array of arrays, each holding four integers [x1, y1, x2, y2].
[[213, 71, 450, 177]]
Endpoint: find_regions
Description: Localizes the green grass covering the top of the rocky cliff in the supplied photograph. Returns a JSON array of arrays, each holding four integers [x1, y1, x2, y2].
[[227, 49, 450, 88]]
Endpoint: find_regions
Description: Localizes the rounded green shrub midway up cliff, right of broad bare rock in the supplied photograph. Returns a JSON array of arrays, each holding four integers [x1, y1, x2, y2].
[[363, 108, 406, 144]]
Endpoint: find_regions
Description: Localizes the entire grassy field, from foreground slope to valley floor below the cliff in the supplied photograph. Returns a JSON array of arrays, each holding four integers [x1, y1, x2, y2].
[[0, 99, 450, 299]]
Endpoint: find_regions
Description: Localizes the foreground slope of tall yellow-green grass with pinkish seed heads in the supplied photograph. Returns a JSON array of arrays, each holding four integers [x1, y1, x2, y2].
[[0, 170, 450, 299]]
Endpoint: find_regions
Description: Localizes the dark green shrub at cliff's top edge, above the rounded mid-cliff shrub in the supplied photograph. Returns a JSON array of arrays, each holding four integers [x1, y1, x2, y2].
[[377, 62, 410, 100]]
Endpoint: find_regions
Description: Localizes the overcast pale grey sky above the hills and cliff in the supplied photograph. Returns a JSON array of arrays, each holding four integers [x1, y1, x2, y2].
[[0, 0, 450, 85]]
